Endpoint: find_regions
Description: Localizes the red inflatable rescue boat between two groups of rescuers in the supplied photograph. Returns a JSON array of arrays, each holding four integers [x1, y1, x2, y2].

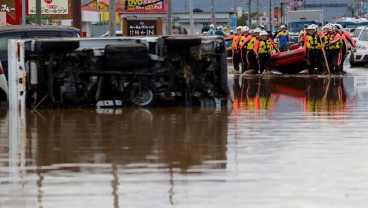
[[271, 47, 306, 74]]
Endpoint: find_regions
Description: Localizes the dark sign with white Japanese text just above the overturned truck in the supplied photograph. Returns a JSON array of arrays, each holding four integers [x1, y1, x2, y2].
[[127, 20, 157, 36]]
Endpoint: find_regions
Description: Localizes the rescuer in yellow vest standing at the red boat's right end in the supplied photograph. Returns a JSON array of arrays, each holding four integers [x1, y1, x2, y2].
[[304, 24, 324, 74]]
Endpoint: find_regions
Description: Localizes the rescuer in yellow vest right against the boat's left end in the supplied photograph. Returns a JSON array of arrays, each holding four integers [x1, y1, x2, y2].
[[254, 31, 278, 74]]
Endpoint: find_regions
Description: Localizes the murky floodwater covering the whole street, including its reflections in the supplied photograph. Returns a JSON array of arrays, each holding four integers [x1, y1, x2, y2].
[[0, 61, 368, 208]]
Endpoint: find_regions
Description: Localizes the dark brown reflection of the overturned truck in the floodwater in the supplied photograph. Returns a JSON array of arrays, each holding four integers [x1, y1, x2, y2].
[[27, 108, 227, 172]]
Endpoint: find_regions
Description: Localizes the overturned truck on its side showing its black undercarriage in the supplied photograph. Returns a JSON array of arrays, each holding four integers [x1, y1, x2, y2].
[[9, 36, 228, 108]]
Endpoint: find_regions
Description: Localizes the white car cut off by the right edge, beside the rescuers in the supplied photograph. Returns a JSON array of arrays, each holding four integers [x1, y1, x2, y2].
[[350, 26, 368, 67]]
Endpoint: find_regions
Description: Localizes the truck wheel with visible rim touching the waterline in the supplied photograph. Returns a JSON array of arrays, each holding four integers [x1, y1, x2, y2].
[[126, 82, 159, 108]]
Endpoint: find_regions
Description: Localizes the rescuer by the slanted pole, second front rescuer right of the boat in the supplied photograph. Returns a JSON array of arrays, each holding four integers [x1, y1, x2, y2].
[[322, 25, 343, 74]]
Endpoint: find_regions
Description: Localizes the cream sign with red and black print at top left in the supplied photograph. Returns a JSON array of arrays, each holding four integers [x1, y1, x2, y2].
[[28, 0, 70, 15]]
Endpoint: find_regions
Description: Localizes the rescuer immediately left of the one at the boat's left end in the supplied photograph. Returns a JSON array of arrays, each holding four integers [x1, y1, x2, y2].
[[241, 28, 261, 73]]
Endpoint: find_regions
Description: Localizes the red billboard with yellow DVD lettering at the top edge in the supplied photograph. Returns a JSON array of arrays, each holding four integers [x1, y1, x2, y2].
[[119, 0, 167, 13]]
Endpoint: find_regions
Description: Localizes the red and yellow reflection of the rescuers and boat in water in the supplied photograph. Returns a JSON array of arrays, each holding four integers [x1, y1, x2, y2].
[[233, 76, 350, 115]]
